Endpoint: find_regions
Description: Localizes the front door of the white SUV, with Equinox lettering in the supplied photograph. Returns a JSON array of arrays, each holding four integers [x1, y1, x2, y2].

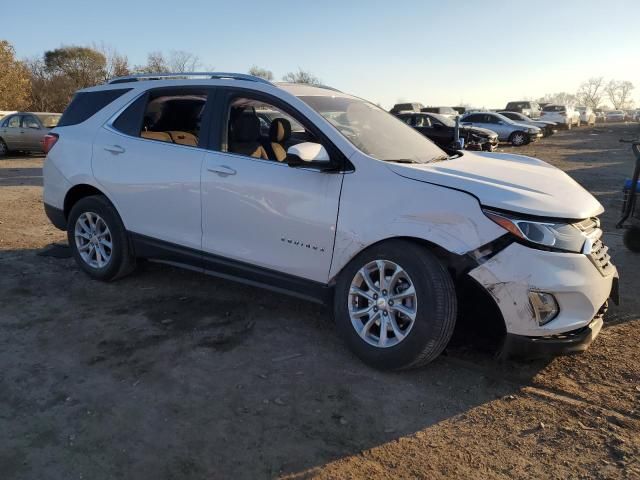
[[202, 92, 343, 283]]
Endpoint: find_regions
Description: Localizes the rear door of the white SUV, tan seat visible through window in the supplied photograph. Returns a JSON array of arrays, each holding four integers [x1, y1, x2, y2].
[[93, 87, 214, 250]]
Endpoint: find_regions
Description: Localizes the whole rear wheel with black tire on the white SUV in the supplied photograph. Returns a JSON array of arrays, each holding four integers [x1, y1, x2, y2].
[[67, 195, 135, 281]]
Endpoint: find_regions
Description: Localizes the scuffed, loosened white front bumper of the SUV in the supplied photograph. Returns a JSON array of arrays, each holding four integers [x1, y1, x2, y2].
[[469, 243, 618, 354]]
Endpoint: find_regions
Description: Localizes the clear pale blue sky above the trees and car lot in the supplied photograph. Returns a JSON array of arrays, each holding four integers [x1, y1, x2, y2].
[[5, 0, 640, 108]]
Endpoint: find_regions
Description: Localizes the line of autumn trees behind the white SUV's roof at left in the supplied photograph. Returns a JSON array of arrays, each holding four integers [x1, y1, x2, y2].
[[0, 40, 321, 112]]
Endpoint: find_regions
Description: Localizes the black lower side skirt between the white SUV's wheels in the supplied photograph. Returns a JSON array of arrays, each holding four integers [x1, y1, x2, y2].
[[128, 232, 333, 305]]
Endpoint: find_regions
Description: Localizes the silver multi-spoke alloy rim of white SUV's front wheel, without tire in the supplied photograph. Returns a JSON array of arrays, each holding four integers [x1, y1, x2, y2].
[[348, 260, 418, 348]]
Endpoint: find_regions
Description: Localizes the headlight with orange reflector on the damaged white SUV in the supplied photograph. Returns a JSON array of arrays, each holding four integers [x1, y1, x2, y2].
[[483, 209, 586, 253]]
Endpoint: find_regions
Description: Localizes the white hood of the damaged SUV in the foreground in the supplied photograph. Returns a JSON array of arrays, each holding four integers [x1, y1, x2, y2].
[[388, 152, 604, 219]]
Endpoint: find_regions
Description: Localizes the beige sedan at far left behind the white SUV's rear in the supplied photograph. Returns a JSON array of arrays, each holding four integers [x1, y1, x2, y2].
[[0, 112, 61, 155]]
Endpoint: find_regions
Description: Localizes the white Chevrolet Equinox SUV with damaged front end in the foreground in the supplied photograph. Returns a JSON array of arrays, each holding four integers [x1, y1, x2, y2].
[[44, 73, 617, 369]]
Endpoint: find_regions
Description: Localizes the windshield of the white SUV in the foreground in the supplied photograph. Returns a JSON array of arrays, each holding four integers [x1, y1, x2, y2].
[[299, 96, 447, 163]]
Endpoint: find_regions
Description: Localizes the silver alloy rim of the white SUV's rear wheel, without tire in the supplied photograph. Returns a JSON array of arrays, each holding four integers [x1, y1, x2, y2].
[[74, 212, 113, 268]]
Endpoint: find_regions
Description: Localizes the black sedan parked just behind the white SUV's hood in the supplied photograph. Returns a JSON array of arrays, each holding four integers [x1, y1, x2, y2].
[[398, 112, 498, 152]]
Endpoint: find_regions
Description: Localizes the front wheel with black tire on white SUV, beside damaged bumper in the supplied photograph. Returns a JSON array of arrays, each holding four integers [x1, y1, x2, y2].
[[334, 240, 458, 370]]
